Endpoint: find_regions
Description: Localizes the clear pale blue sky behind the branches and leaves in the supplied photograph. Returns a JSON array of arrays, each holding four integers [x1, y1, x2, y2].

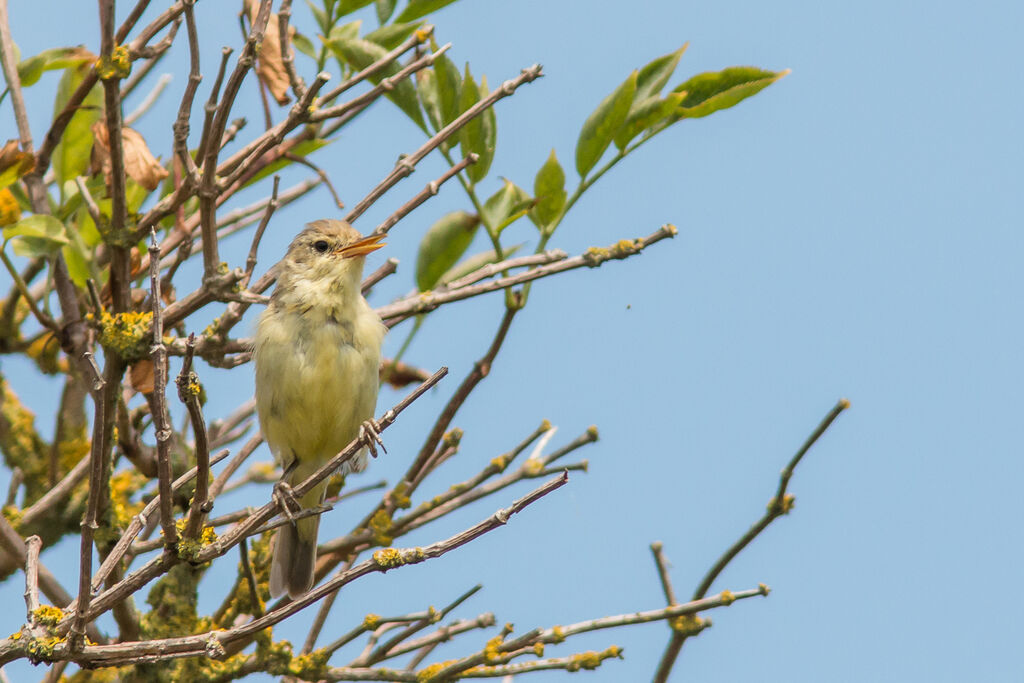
[[0, 0, 1024, 681]]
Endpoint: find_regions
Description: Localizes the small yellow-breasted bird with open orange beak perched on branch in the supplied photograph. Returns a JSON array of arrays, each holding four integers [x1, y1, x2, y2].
[[253, 219, 386, 599]]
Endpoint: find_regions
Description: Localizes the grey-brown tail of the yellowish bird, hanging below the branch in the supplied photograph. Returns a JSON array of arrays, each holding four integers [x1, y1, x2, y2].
[[270, 481, 327, 598]]
